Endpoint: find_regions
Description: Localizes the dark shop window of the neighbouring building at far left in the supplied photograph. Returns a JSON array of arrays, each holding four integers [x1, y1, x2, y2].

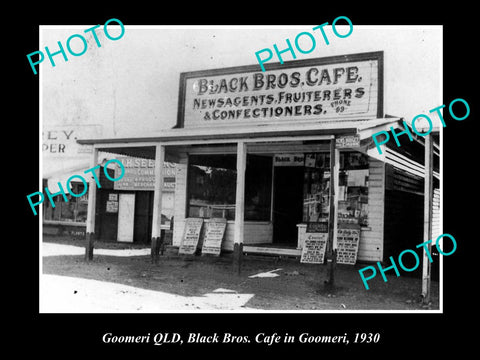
[[43, 182, 88, 223]]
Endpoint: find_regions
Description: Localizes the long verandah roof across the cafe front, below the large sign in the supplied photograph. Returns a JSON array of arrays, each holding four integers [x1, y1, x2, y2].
[[77, 117, 439, 177]]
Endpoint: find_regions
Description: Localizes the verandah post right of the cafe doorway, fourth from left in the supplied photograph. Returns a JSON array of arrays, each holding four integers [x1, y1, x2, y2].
[[325, 138, 340, 289]]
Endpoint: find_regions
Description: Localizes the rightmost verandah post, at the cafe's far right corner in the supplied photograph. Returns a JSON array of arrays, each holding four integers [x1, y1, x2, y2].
[[422, 135, 433, 305]]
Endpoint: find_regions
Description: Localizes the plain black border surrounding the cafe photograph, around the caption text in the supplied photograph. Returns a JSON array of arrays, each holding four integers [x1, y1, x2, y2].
[[15, 1, 479, 358]]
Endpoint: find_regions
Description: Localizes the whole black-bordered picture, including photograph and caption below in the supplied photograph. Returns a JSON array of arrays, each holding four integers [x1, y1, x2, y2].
[[15, 4, 477, 358]]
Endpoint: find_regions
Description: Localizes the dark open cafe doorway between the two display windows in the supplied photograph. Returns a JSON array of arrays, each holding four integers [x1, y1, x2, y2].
[[273, 166, 304, 247]]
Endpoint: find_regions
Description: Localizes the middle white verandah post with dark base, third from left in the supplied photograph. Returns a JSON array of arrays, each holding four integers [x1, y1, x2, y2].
[[233, 141, 247, 274]]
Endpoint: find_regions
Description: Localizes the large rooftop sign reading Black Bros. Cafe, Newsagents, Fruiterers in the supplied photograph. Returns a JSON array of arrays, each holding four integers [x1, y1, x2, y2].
[[177, 52, 383, 127]]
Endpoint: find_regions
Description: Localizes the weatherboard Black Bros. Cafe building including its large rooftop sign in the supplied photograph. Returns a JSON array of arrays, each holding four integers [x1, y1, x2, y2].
[[78, 52, 439, 268]]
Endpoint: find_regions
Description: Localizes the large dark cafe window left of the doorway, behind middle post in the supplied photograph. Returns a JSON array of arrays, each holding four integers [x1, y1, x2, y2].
[[187, 154, 272, 221]]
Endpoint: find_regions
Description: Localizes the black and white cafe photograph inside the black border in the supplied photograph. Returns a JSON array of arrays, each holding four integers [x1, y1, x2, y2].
[[37, 23, 442, 313]]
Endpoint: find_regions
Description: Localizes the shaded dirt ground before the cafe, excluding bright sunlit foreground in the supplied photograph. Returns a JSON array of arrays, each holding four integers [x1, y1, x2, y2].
[[42, 236, 439, 312]]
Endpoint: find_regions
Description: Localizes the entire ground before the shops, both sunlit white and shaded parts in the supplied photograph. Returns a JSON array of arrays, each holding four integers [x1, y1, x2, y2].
[[40, 237, 439, 313]]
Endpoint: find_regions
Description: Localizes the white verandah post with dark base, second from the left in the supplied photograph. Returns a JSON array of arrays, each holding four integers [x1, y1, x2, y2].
[[150, 145, 165, 264]]
